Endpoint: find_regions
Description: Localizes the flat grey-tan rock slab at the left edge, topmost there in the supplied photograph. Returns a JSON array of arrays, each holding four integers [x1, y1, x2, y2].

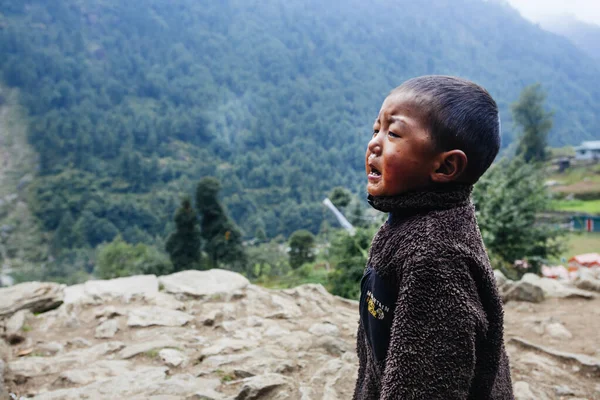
[[0, 282, 65, 319]]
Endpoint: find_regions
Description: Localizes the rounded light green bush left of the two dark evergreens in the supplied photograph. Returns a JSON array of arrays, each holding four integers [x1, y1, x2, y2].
[[94, 236, 173, 279]]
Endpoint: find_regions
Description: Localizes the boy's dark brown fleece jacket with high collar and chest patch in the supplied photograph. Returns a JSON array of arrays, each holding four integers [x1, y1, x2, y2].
[[354, 186, 513, 400]]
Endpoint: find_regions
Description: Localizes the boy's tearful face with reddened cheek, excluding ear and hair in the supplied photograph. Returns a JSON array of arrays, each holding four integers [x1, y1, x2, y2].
[[365, 92, 437, 196]]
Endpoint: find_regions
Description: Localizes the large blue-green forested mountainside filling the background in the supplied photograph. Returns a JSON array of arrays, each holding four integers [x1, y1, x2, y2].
[[0, 0, 600, 266]]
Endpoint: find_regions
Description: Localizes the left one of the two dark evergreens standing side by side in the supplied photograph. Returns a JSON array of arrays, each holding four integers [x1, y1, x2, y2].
[[165, 197, 201, 271]]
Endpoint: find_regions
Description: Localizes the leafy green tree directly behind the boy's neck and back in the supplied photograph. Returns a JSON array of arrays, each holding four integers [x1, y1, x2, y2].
[[473, 158, 563, 276]]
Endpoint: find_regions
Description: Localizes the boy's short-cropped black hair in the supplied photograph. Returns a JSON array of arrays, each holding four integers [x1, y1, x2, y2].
[[392, 75, 501, 183]]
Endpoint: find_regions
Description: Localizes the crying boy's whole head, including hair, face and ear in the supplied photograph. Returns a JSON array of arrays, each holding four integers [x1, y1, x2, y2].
[[365, 76, 500, 196]]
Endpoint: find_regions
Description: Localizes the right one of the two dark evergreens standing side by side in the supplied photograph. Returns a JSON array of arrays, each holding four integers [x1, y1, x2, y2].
[[196, 177, 246, 270]]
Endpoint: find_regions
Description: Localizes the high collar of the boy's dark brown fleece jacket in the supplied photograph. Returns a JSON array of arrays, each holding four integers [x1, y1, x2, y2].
[[367, 184, 473, 215]]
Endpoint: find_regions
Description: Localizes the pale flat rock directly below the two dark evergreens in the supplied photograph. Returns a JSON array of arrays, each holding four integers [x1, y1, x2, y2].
[[159, 269, 250, 298]]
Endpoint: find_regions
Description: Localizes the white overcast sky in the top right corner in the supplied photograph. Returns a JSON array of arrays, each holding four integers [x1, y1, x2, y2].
[[508, 0, 600, 25]]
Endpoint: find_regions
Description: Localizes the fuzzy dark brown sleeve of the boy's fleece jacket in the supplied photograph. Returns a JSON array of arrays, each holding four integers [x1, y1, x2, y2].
[[381, 261, 481, 400]]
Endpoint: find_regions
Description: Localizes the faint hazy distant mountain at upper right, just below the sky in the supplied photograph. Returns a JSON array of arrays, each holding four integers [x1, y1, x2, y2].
[[541, 15, 600, 63]]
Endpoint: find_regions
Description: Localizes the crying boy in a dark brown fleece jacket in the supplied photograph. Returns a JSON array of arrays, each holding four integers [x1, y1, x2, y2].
[[354, 76, 513, 400]]
